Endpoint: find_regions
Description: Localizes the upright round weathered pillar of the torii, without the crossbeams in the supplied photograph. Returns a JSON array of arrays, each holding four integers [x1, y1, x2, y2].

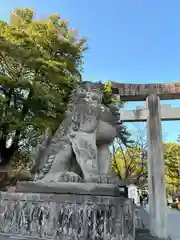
[[146, 94, 167, 239]]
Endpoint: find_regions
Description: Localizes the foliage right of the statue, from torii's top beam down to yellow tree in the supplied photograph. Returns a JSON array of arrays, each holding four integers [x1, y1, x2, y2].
[[103, 81, 143, 185]]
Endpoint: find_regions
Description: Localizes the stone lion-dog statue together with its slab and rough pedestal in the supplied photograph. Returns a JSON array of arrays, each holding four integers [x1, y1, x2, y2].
[[3, 81, 135, 240]]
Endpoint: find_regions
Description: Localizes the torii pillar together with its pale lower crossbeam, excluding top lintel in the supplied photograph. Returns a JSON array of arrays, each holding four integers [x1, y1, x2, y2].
[[118, 94, 180, 238]]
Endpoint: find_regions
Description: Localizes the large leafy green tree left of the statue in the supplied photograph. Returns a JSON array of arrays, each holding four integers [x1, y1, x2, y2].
[[0, 9, 86, 165]]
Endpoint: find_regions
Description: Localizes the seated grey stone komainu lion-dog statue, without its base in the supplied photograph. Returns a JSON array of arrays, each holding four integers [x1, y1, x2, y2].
[[32, 83, 116, 182]]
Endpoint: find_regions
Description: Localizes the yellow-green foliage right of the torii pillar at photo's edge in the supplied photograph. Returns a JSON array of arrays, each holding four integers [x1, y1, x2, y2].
[[163, 142, 180, 193]]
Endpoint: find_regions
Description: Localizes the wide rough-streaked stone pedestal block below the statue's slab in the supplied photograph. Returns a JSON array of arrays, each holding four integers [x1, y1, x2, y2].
[[0, 192, 135, 240]]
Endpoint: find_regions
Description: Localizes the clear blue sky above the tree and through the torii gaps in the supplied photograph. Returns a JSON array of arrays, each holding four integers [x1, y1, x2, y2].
[[0, 0, 180, 141]]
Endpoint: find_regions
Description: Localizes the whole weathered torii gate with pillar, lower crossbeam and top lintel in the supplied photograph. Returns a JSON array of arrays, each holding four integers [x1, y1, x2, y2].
[[111, 82, 180, 238]]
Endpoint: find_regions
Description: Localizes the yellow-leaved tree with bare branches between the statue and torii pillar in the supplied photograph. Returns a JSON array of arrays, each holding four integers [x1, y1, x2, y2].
[[112, 130, 148, 187]]
